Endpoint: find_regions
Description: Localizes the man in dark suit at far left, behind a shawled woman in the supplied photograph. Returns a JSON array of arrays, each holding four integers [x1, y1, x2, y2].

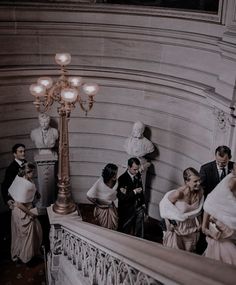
[[1, 143, 26, 207]]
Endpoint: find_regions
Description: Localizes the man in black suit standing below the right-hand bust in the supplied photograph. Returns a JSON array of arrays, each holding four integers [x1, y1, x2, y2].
[[117, 157, 145, 238]]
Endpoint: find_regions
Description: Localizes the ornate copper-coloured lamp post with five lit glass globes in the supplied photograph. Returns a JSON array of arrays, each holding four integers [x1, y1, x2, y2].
[[30, 53, 98, 215]]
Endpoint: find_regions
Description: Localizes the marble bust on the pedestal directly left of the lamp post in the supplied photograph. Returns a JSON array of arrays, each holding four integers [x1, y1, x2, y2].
[[30, 113, 58, 154]]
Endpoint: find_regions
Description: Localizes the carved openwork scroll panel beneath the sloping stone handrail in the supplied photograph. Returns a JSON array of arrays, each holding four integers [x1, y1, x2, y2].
[[51, 228, 162, 285]]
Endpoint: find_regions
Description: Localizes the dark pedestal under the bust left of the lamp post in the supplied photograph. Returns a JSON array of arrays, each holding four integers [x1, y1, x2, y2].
[[34, 150, 58, 209]]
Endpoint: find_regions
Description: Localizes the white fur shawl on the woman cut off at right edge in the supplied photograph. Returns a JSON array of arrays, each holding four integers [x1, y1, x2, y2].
[[203, 173, 236, 230]]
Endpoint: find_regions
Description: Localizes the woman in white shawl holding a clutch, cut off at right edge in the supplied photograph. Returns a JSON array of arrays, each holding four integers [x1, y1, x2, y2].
[[202, 164, 236, 265]]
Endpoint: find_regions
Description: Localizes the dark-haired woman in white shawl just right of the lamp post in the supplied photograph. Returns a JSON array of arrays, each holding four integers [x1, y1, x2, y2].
[[87, 163, 118, 230]]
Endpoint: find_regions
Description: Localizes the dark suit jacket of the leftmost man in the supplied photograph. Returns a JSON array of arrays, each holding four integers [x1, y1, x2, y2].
[[1, 160, 26, 204]]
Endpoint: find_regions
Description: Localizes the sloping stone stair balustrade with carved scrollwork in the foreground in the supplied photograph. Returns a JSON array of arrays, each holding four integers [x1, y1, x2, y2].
[[47, 208, 235, 285]]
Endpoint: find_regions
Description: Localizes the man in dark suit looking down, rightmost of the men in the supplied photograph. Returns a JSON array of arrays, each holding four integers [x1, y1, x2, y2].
[[200, 145, 234, 198]]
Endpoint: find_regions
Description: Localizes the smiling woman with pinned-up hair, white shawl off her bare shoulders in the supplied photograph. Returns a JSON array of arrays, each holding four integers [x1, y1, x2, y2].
[[160, 167, 204, 252]]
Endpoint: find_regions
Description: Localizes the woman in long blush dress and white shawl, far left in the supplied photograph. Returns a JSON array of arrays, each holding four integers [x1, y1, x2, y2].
[[8, 162, 42, 263]]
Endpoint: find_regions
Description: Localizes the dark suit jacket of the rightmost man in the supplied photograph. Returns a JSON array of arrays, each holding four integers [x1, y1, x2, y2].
[[200, 160, 234, 198]]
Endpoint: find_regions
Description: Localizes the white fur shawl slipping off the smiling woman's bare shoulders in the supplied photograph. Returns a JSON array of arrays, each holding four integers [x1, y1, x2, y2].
[[159, 190, 204, 222]]
